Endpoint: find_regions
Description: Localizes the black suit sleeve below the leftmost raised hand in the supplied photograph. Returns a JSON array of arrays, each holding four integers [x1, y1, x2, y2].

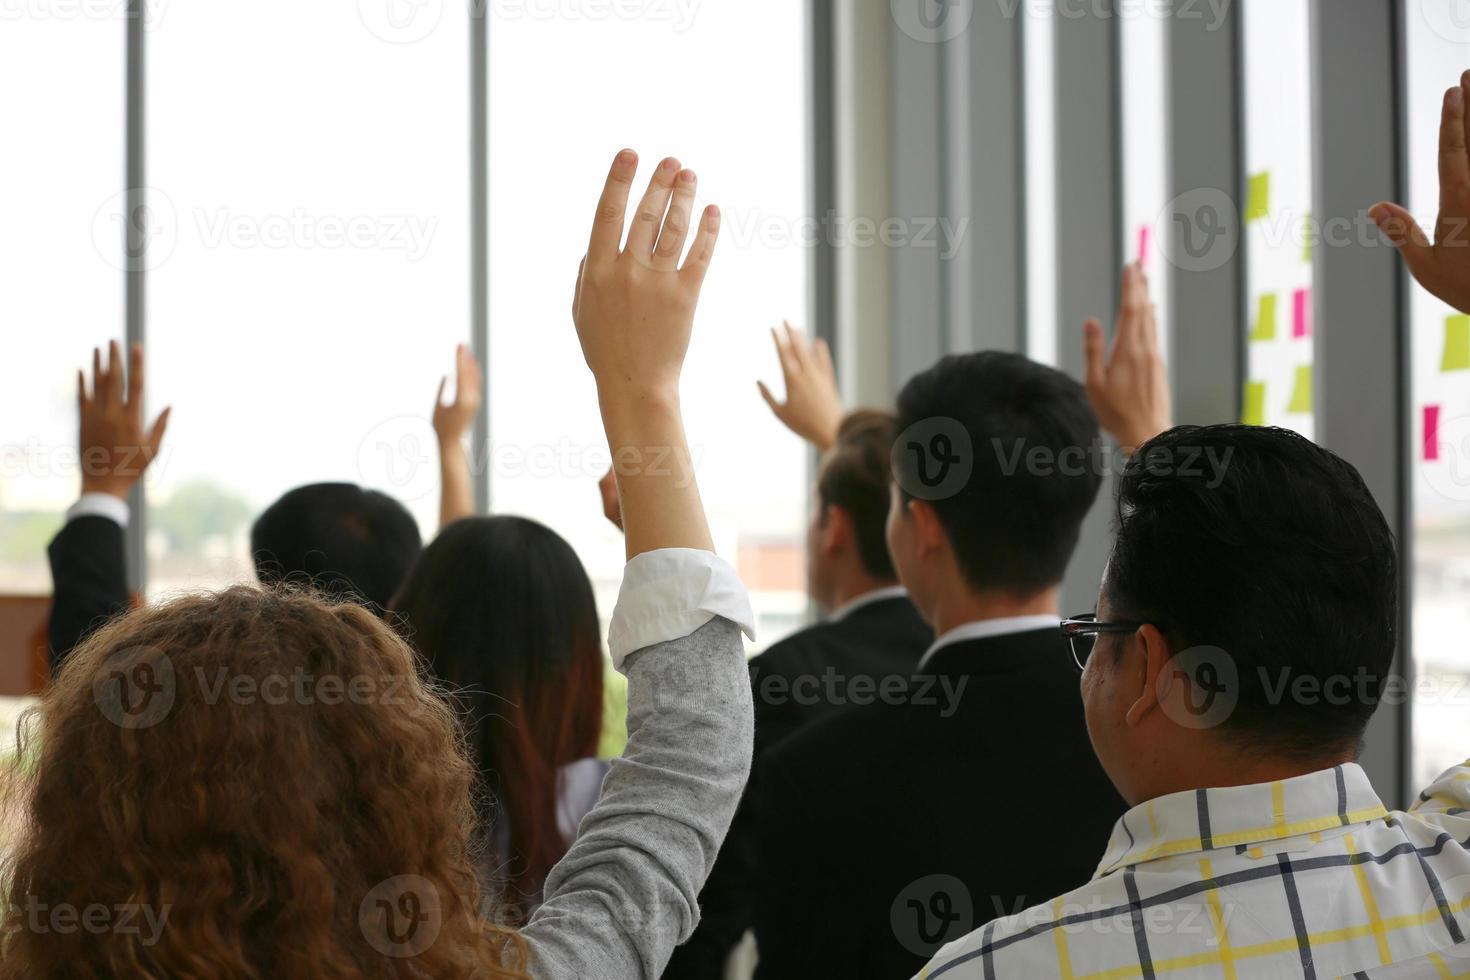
[[47, 514, 128, 676]]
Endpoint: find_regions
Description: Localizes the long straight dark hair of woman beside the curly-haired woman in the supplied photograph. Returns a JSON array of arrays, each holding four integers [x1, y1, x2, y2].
[[394, 517, 603, 916]]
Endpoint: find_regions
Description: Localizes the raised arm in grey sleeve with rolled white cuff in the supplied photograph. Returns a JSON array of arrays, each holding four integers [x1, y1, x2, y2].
[[525, 151, 753, 980]]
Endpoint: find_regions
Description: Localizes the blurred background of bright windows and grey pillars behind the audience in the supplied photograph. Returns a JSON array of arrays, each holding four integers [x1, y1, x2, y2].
[[0, 0, 1470, 811]]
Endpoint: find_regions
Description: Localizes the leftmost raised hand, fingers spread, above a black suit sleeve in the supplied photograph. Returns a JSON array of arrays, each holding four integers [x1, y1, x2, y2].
[[76, 341, 171, 500]]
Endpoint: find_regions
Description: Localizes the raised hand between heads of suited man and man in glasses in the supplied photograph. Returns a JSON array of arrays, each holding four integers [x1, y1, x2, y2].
[[1083, 264, 1173, 453]]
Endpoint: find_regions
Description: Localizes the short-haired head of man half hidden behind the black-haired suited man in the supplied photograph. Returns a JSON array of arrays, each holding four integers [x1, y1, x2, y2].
[[817, 408, 898, 582]]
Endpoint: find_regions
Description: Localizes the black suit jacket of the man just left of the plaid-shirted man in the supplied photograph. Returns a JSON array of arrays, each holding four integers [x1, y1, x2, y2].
[[750, 629, 1125, 980]]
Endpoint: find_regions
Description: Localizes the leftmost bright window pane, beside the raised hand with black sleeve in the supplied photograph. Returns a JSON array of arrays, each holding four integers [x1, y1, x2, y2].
[[0, 3, 126, 595]]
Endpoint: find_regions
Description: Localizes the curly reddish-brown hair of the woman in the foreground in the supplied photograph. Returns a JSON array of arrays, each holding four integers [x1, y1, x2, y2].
[[0, 586, 526, 979]]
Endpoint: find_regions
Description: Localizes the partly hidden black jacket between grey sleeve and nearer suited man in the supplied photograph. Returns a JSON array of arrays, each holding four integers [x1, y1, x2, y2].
[[663, 597, 933, 980]]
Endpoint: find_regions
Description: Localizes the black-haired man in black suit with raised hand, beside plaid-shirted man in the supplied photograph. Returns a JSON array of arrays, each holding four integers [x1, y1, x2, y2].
[[750, 267, 1167, 977]]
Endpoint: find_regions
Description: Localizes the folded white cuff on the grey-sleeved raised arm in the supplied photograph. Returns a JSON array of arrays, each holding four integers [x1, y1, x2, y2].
[[607, 548, 756, 670]]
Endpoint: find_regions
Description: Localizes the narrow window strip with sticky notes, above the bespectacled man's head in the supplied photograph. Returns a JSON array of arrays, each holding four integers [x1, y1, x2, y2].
[[1241, 0, 1316, 438]]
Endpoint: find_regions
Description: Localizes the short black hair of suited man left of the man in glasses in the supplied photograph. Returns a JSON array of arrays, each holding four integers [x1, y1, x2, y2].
[[895, 351, 1103, 597]]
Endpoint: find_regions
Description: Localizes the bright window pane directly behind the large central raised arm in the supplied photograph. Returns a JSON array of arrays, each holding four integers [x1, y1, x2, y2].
[[490, 0, 822, 644]]
